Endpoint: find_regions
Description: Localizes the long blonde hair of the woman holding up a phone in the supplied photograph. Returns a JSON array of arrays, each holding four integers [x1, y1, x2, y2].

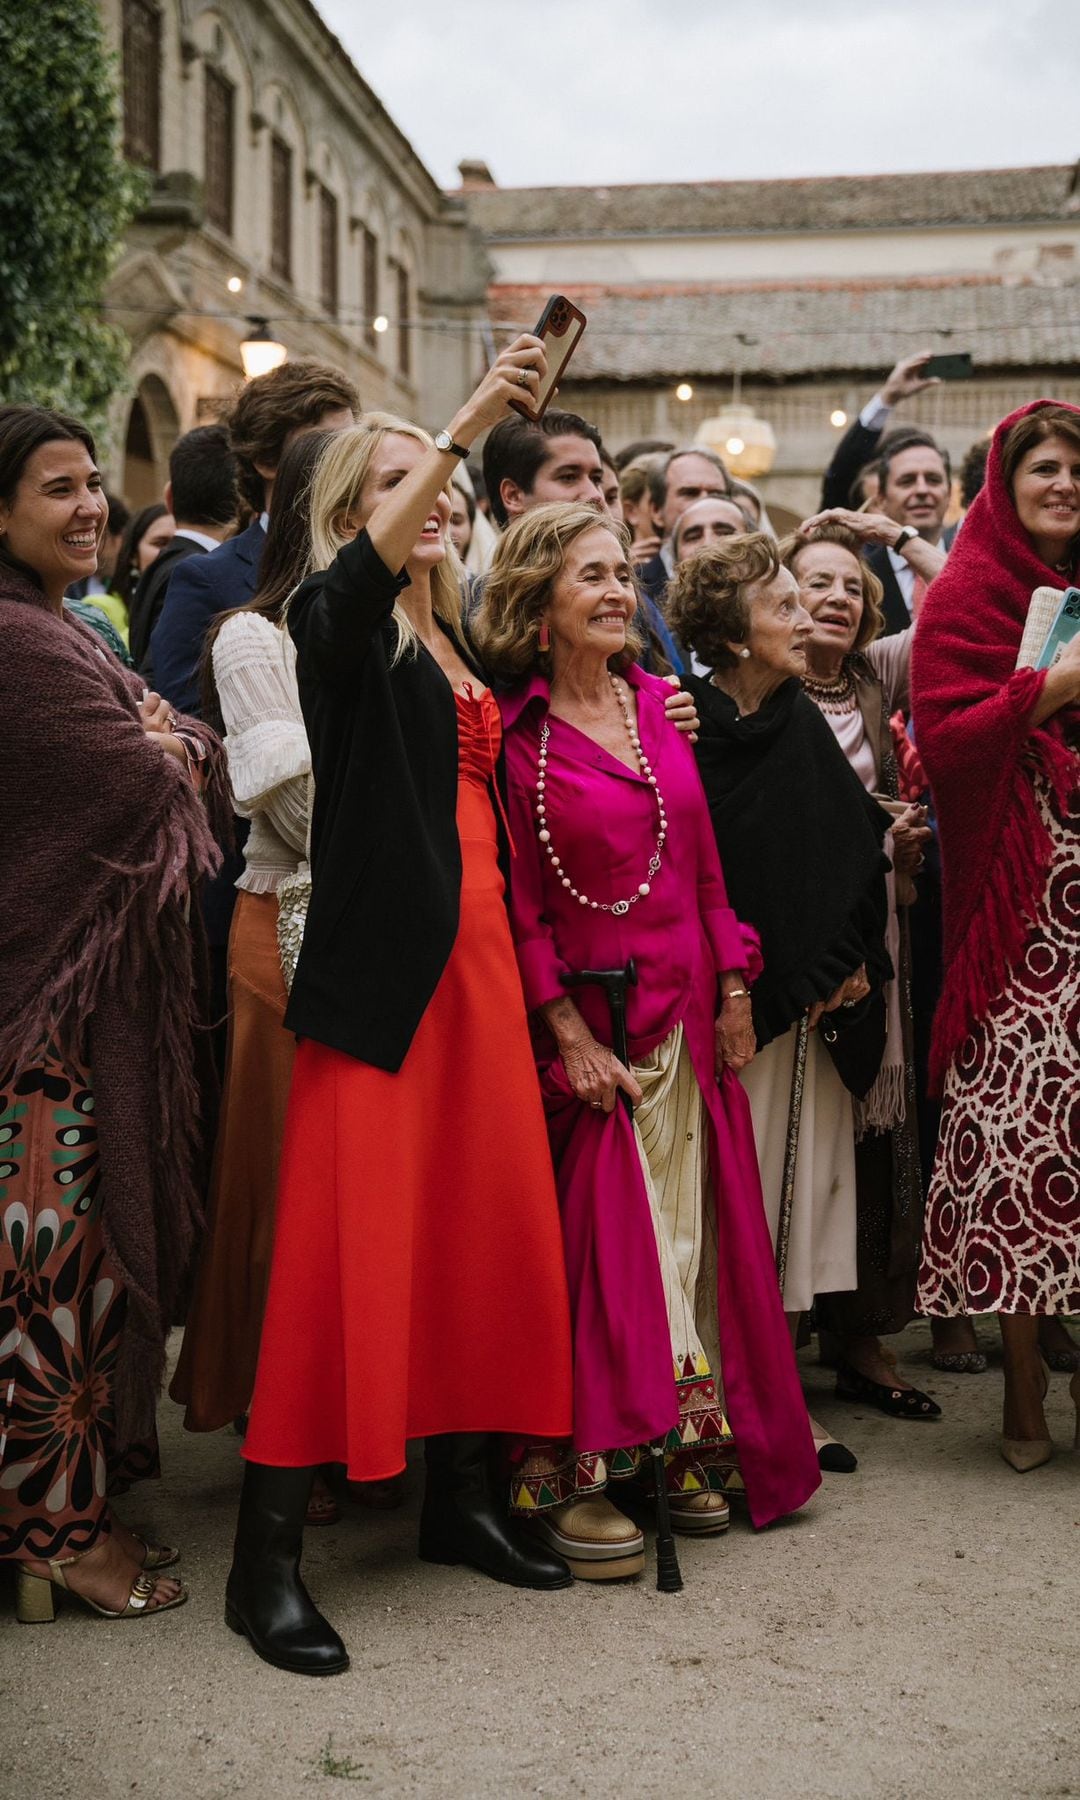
[[304, 412, 464, 662]]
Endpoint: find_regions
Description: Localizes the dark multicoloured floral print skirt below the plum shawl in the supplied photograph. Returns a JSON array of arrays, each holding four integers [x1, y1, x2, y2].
[[0, 1042, 158, 1559]]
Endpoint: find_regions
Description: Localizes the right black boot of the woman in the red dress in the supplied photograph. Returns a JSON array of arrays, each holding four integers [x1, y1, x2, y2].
[[419, 1431, 574, 1588]]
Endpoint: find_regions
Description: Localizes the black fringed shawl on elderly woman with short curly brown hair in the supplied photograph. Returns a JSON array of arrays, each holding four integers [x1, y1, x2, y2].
[[686, 677, 893, 1048]]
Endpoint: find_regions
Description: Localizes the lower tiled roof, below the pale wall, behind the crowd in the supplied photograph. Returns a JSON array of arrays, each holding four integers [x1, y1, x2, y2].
[[488, 277, 1080, 383]]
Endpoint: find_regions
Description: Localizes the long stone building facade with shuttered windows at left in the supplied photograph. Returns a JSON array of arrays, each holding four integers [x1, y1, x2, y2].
[[101, 0, 486, 504]]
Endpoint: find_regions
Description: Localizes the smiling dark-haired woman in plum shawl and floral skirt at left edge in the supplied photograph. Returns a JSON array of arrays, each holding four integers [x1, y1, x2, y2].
[[0, 407, 227, 1622]]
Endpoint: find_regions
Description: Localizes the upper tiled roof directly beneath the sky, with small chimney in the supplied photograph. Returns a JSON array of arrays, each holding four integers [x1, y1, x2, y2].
[[461, 164, 1076, 239]]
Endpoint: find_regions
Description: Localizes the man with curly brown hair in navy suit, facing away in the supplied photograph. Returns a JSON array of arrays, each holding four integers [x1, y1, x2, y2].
[[149, 362, 360, 716]]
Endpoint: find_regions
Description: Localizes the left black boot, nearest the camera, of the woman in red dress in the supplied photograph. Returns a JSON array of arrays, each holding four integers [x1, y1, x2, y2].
[[225, 1463, 349, 1676]]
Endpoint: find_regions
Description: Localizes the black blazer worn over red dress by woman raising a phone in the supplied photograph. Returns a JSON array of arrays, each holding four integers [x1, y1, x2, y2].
[[284, 531, 508, 1073]]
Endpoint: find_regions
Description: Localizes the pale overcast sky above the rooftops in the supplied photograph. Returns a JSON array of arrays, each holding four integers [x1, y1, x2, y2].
[[317, 0, 1080, 187]]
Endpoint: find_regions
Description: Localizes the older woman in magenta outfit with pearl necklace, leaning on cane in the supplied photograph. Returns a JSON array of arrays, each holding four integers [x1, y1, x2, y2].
[[475, 506, 819, 1579]]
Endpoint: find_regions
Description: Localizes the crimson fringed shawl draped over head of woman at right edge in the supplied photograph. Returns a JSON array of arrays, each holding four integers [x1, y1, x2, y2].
[[911, 400, 1080, 1091]]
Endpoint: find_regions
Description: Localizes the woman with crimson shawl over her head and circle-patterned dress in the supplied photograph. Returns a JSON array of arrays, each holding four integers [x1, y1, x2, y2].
[[911, 400, 1080, 1471]]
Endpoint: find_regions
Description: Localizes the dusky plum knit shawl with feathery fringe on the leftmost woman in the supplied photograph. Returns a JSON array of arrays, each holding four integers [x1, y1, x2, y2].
[[0, 563, 227, 1449]]
